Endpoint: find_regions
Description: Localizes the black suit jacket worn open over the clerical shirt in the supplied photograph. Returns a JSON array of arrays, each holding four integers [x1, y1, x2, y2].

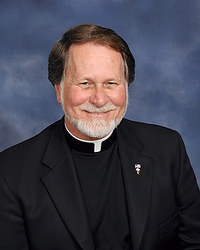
[[0, 119, 200, 250]]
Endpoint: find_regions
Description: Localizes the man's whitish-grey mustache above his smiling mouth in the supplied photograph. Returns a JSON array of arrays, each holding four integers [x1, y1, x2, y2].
[[80, 103, 116, 113]]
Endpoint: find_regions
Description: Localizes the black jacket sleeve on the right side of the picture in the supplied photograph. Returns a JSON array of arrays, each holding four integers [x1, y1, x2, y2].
[[176, 133, 200, 250]]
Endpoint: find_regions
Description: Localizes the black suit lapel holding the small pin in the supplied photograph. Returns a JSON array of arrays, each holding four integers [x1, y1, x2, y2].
[[117, 122, 153, 250]]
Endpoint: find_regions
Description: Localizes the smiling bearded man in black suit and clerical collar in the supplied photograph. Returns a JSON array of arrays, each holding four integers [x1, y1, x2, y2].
[[0, 24, 200, 250]]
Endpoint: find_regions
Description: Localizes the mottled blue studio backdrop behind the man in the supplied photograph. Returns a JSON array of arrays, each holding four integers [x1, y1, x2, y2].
[[0, 0, 200, 186]]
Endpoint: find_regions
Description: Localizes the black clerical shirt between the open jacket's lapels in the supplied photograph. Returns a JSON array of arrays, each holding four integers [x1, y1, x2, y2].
[[65, 126, 132, 250]]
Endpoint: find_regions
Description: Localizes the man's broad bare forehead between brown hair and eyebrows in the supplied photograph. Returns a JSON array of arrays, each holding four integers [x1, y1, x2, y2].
[[65, 42, 125, 81]]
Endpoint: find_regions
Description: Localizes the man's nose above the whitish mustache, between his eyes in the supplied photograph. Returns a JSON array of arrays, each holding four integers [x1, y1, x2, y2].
[[90, 85, 108, 107]]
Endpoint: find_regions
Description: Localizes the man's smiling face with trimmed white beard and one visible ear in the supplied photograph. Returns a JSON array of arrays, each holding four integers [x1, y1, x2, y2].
[[55, 42, 128, 140]]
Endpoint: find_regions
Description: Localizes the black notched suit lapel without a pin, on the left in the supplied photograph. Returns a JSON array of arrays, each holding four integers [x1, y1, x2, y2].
[[42, 119, 94, 250]]
